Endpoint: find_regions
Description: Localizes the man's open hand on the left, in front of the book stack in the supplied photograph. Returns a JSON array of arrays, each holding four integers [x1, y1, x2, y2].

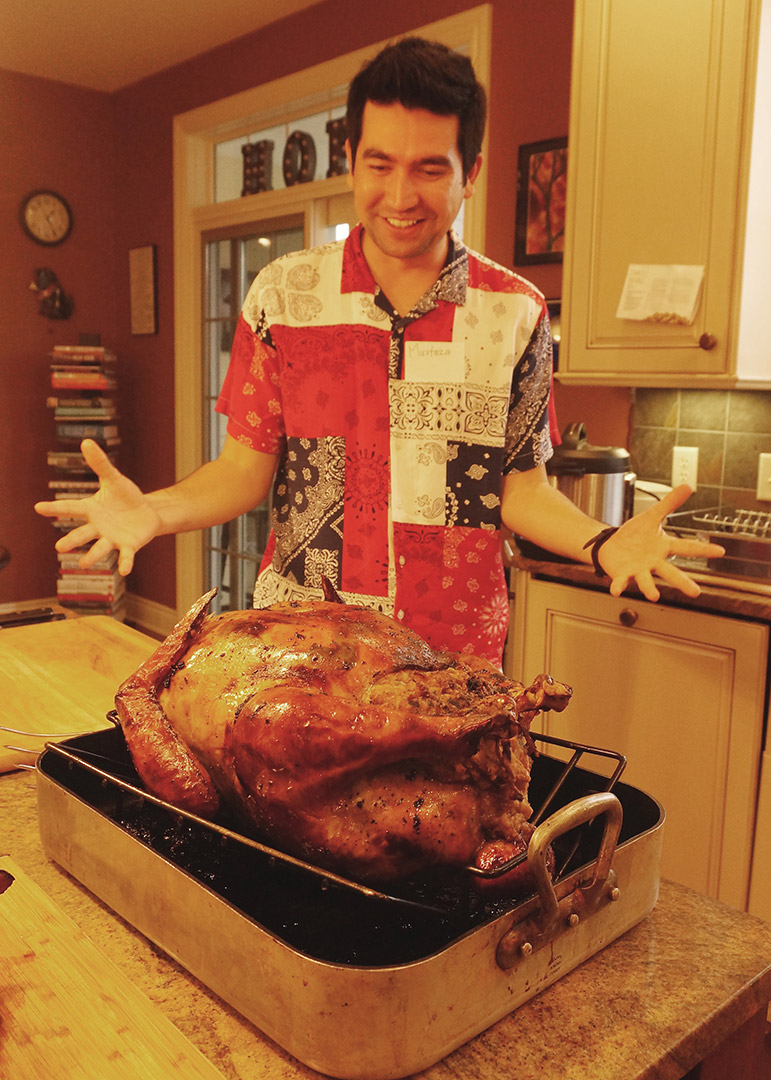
[[35, 438, 161, 577]]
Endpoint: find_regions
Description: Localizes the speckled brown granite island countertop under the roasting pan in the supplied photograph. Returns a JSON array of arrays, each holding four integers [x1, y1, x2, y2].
[[0, 772, 771, 1080]]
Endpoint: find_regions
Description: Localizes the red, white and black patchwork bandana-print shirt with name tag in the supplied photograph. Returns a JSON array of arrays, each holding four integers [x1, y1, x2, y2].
[[217, 226, 552, 664]]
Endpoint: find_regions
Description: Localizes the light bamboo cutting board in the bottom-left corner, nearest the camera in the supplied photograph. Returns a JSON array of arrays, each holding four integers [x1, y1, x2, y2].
[[0, 859, 221, 1080]]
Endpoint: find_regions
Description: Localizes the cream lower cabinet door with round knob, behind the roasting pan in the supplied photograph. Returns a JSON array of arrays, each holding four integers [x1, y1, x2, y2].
[[510, 573, 768, 909]]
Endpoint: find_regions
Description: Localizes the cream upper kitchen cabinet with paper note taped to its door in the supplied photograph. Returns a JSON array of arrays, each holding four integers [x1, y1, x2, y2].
[[558, 0, 771, 387]]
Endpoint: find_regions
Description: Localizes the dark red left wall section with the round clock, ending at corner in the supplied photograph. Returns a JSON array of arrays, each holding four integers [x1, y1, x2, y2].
[[0, 70, 118, 602]]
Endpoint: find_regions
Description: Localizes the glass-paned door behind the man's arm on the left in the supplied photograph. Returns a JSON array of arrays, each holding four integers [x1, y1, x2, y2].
[[203, 217, 305, 612]]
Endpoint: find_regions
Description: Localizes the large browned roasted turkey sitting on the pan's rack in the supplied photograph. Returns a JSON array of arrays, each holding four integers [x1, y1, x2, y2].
[[116, 590, 571, 882]]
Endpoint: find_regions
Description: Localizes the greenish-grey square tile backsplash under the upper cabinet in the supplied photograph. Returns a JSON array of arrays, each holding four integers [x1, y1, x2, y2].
[[631, 389, 771, 511]]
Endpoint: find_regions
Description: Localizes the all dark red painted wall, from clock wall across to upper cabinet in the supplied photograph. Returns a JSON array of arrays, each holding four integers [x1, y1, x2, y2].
[[0, 0, 613, 607]]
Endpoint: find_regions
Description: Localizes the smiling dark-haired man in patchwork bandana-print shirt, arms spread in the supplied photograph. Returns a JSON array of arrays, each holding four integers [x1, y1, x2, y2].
[[37, 38, 721, 663]]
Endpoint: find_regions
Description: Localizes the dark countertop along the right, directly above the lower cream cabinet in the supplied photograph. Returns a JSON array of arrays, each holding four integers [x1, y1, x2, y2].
[[508, 545, 771, 622]]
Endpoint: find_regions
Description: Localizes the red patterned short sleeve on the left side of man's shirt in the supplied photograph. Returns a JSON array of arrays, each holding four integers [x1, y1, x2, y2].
[[215, 315, 285, 454]]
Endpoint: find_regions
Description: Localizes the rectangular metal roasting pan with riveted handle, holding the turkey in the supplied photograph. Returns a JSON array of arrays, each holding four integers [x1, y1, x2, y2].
[[36, 729, 664, 1080]]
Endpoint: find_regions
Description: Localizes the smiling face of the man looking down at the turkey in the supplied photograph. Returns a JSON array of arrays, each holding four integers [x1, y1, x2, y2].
[[347, 102, 482, 272]]
